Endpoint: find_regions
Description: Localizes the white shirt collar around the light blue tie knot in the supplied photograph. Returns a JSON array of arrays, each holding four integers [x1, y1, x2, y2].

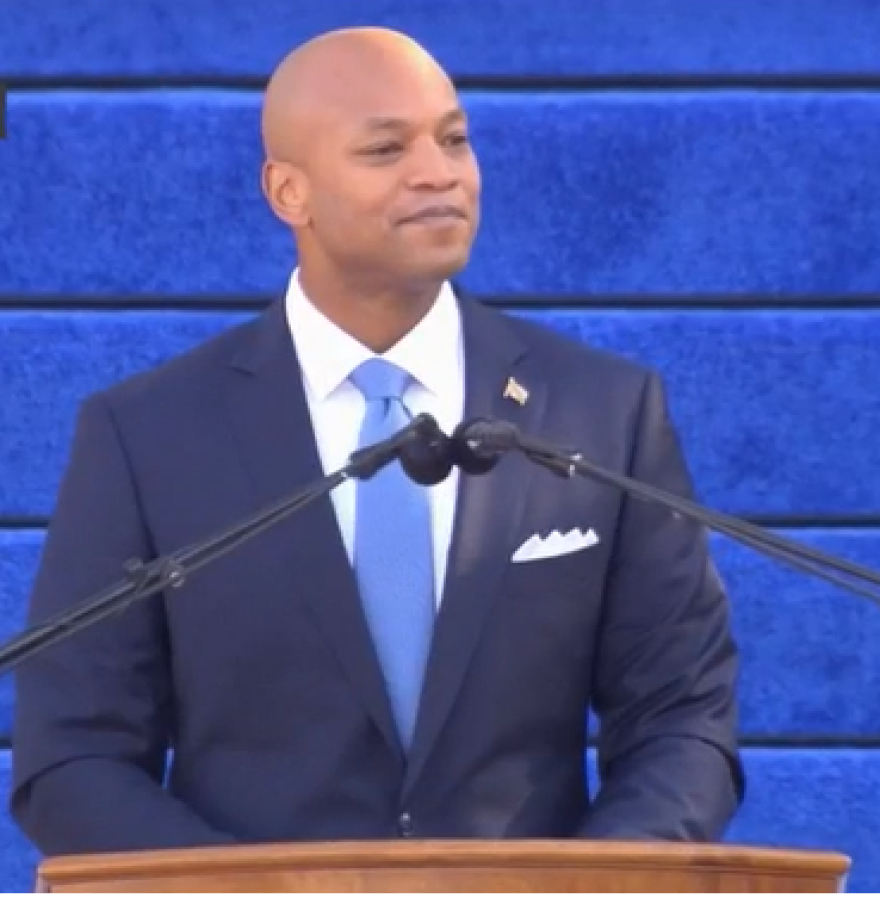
[[285, 270, 462, 401]]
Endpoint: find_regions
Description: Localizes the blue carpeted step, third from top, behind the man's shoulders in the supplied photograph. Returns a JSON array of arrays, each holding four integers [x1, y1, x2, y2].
[[0, 309, 880, 518]]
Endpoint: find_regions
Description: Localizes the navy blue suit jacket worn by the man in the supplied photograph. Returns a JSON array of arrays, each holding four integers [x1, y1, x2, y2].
[[11, 299, 742, 854]]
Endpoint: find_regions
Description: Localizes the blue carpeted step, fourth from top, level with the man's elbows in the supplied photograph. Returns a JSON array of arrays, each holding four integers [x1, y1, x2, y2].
[[0, 529, 880, 739]]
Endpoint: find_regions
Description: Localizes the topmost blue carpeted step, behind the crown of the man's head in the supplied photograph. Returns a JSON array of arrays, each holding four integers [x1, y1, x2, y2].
[[0, 0, 880, 77]]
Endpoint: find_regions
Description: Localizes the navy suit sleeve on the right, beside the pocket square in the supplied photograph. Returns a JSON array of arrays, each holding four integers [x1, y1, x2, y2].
[[580, 375, 744, 842]]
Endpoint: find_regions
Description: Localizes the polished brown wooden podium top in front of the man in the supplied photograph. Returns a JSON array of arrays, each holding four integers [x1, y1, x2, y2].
[[38, 840, 850, 892]]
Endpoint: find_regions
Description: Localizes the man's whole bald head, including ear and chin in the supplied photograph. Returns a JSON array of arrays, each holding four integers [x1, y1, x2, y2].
[[262, 28, 480, 304]]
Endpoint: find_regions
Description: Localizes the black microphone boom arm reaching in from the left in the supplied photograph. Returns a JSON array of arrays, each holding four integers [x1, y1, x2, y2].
[[0, 415, 444, 674]]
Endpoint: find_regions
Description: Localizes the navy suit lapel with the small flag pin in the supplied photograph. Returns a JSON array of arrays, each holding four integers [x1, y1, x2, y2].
[[404, 299, 546, 800]]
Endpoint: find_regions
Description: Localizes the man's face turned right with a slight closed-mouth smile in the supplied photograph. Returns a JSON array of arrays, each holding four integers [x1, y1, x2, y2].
[[306, 69, 480, 280]]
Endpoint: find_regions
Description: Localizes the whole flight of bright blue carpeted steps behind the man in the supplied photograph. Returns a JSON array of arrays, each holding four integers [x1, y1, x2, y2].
[[0, 0, 880, 891]]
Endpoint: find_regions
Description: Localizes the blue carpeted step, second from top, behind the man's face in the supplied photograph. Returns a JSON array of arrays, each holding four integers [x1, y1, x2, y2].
[[0, 90, 880, 302]]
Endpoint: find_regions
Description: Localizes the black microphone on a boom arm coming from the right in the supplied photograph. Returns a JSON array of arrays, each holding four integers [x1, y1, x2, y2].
[[452, 418, 880, 604]]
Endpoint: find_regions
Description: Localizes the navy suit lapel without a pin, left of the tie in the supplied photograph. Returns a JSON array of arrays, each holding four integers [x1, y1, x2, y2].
[[223, 301, 401, 753]]
